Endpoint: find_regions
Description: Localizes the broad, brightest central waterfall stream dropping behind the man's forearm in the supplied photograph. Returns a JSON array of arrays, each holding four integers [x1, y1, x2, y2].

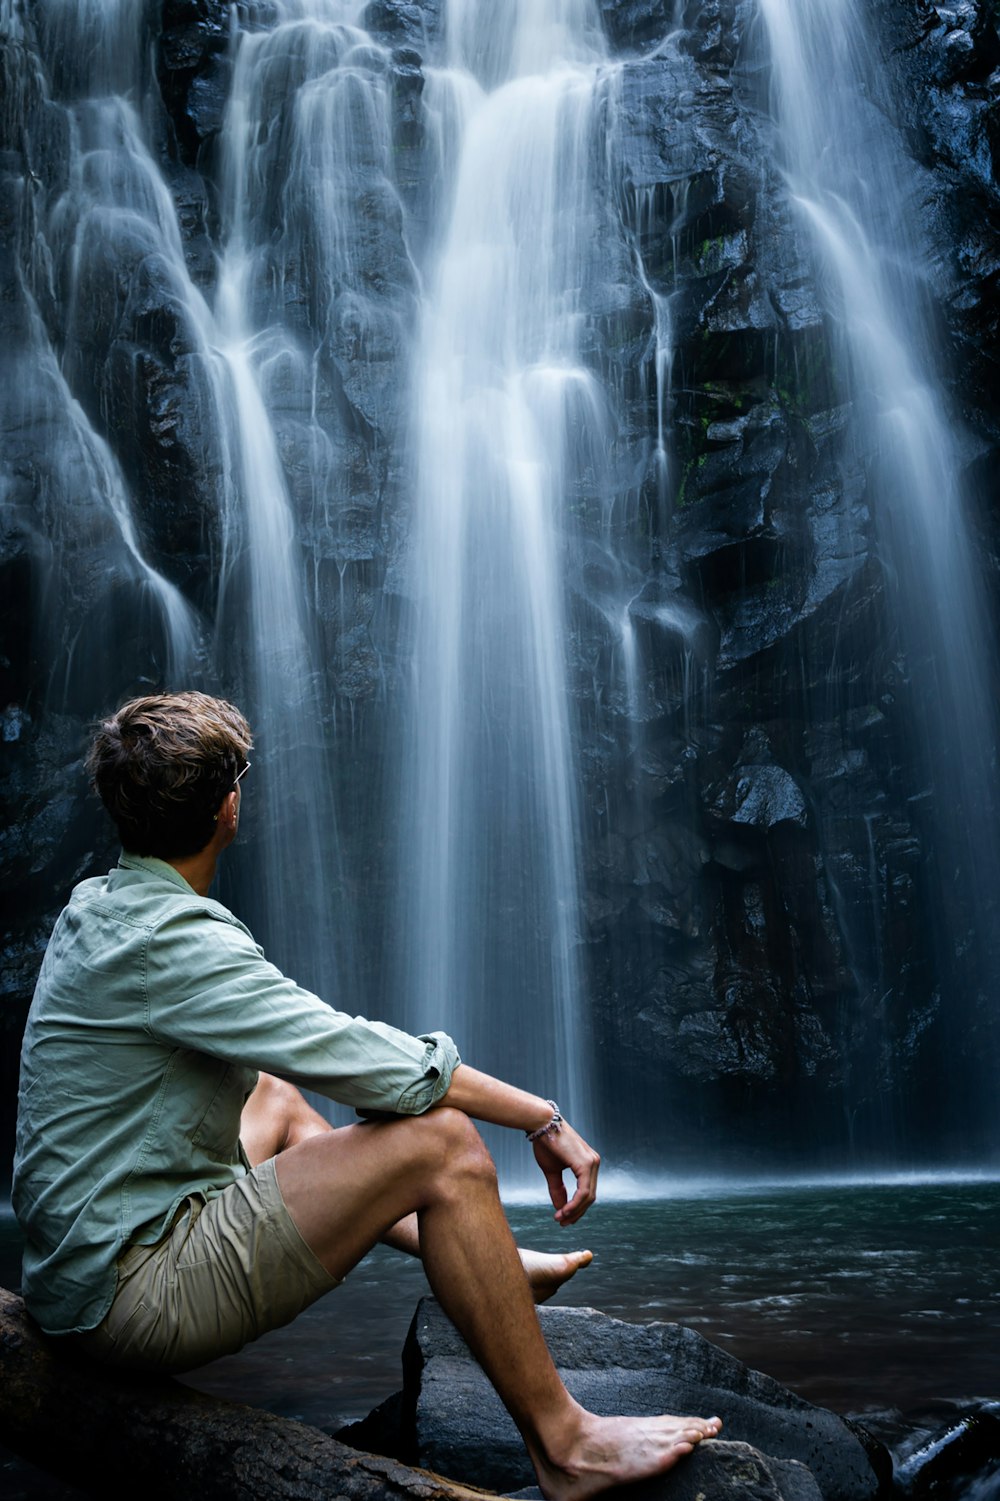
[[401, 0, 605, 1158]]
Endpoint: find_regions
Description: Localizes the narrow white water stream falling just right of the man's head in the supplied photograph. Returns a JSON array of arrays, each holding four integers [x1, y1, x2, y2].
[[205, 3, 378, 1004]]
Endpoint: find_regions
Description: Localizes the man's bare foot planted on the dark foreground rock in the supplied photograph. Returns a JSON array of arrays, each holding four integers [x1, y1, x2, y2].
[[533, 1411, 722, 1501]]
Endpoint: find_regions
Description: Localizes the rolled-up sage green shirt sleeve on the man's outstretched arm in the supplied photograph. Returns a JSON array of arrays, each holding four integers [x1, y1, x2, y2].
[[144, 908, 461, 1115]]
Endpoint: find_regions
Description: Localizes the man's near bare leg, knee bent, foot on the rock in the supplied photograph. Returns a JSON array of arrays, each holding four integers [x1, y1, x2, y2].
[[275, 1109, 721, 1501]]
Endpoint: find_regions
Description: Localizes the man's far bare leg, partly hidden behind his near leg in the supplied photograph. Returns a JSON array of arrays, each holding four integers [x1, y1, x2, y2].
[[240, 1073, 593, 1303]]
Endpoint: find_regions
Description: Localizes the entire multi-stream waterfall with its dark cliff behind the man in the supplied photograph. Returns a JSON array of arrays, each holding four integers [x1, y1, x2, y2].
[[7, 0, 1000, 1177]]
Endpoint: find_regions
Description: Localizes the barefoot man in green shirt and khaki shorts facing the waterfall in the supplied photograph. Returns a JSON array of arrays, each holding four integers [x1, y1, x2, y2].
[[14, 692, 722, 1501]]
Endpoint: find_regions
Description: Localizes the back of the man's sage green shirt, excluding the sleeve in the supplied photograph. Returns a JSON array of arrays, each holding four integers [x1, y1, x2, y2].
[[12, 856, 257, 1334]]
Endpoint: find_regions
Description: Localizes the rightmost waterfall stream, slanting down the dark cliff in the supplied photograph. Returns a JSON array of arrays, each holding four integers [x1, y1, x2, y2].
[[760, 0, 1000, 1127]]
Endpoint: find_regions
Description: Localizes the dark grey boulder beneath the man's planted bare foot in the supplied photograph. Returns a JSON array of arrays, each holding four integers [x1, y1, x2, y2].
[[340, 1298, 889, 1501]]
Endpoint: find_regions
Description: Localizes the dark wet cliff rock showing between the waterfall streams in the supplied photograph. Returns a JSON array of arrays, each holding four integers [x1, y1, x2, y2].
[[0, 0, 1000, 1170]]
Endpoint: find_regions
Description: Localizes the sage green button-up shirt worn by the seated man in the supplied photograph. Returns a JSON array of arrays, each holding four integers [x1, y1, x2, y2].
[[12, 854, 459, 1334]]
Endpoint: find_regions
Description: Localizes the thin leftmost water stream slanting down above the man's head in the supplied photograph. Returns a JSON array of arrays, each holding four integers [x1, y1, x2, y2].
[[3, 0, 201, 690]]
